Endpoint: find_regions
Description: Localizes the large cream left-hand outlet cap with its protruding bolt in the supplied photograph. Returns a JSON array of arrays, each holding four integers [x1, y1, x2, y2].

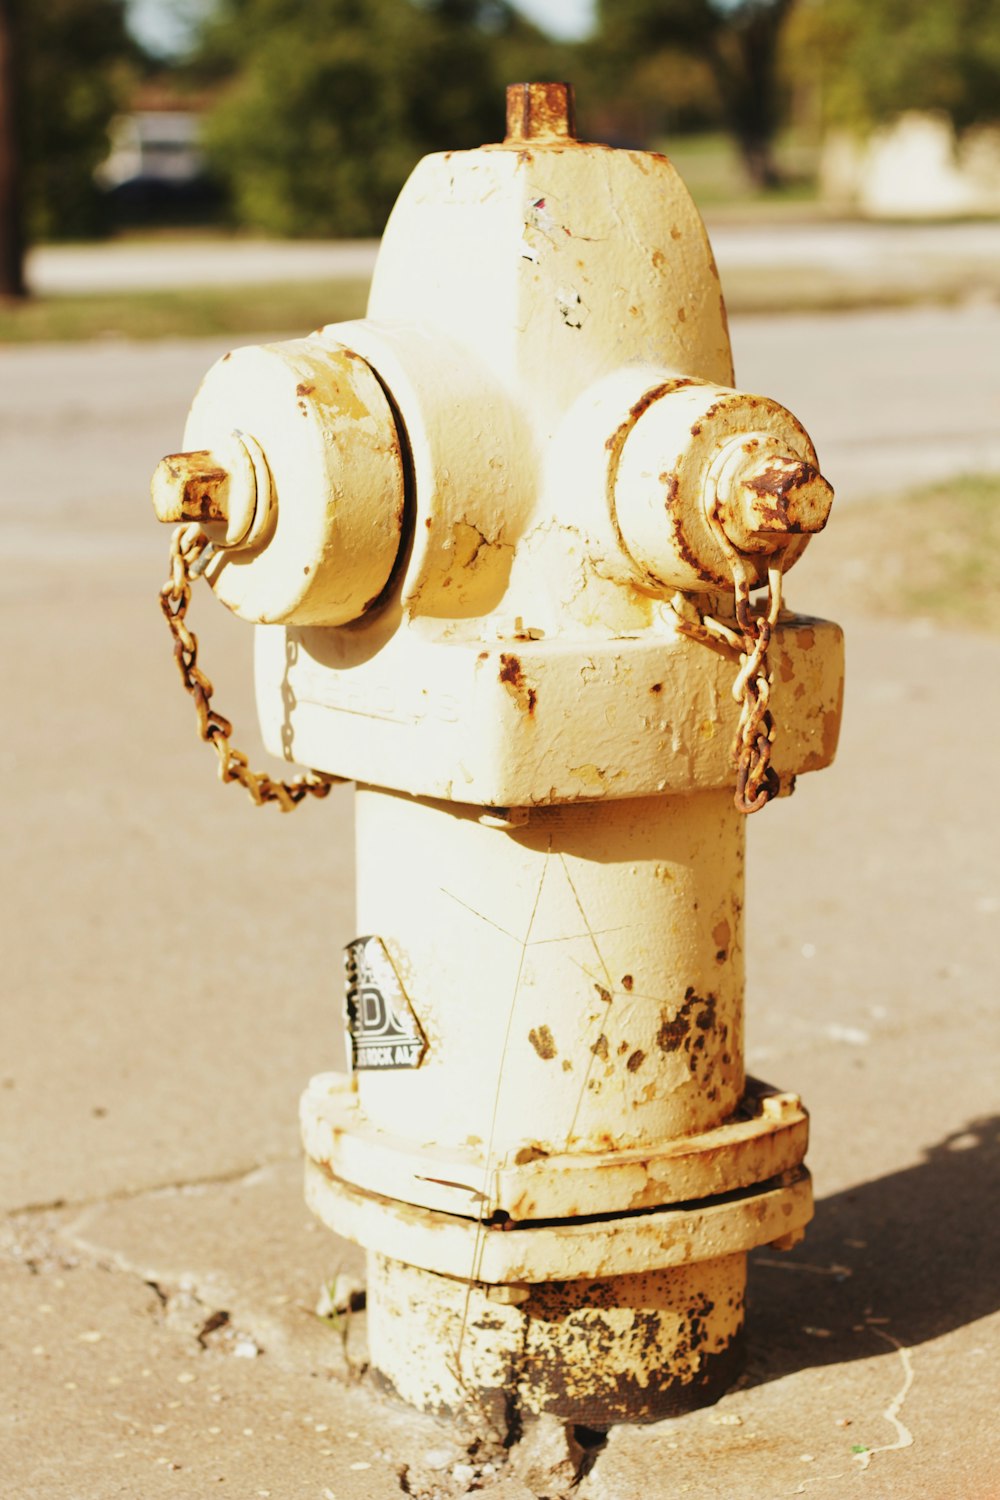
[[153, 333, 406, 626]]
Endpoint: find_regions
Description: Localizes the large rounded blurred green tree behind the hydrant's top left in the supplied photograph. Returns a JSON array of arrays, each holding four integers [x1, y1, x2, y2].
[[198, 0, 563, 236]]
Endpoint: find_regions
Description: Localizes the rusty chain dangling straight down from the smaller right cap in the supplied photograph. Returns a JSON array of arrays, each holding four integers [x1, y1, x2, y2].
[[670, 540, 783, 813]]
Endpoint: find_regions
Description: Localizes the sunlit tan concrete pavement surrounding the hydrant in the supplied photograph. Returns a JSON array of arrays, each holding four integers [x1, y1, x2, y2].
[[0, 312, 1000, 1500]]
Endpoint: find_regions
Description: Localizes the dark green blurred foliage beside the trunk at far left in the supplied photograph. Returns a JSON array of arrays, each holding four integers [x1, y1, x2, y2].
[[19, 0, 136, 239]]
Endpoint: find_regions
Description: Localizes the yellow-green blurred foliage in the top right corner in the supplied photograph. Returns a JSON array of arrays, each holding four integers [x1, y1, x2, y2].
[[789, 0, 1000, 131]]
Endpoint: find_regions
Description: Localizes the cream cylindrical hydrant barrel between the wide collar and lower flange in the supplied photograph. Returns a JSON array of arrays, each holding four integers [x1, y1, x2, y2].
[[350, 789, 745, 1146]]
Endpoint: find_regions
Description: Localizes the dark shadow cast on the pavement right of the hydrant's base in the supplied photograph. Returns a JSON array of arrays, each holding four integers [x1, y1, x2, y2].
[[742, 1115, 1000, 1386]]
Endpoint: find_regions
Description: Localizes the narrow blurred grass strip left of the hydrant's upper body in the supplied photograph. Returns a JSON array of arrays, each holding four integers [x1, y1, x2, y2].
[[0, 279, 367, 344]]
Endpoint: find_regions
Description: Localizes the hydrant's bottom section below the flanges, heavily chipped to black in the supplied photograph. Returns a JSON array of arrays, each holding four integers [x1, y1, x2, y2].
[[367, 1253, 747, 1431]]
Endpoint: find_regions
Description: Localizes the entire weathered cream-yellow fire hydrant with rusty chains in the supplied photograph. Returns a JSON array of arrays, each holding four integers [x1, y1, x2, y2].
[[153, 84, 843, 1427]]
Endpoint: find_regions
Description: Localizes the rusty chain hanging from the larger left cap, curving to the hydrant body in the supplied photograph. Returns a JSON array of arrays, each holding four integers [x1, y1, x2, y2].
[[160, 525, 337, 813]]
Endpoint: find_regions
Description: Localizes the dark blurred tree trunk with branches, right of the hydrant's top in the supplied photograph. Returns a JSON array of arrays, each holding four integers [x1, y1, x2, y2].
[[597, 0, 795, 188]]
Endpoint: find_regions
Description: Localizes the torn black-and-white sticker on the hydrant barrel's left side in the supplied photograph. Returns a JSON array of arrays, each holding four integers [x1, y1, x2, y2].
[[343, 938, 427, 1071]]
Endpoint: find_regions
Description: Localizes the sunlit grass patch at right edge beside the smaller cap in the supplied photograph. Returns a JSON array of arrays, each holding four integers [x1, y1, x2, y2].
[[810, 474, 1000, 635]]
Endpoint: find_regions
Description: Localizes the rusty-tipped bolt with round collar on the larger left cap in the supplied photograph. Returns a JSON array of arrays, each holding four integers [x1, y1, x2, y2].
[[151, 432, 271, 548]]
